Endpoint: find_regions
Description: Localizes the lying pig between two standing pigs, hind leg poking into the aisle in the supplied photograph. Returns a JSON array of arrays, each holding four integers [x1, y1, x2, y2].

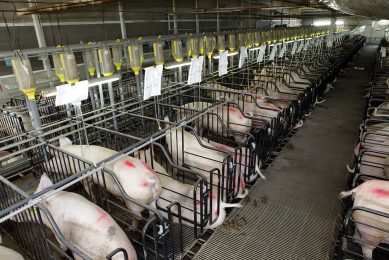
[[137, 148, 242, 229]]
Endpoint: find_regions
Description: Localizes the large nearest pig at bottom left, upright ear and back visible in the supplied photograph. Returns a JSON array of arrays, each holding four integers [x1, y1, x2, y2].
[[35, 174, 137, 260]]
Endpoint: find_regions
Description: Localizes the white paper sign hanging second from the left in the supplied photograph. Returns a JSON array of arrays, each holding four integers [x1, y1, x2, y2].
[[143, 65, 163, 100]]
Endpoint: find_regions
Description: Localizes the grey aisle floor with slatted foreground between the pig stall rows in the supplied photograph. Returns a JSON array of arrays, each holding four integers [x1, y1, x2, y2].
[[196, 46, 377, 260]]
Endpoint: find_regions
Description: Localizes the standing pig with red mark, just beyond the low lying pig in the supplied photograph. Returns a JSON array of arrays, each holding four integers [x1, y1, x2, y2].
[[164, 116, 248, 198]]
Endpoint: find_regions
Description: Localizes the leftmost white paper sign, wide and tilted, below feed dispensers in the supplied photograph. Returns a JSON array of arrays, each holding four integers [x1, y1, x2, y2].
[[55, 80, 89, 106]]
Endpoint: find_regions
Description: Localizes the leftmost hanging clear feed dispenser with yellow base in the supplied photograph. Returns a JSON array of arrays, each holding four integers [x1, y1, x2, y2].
[[12, 56, 36, 100]]
